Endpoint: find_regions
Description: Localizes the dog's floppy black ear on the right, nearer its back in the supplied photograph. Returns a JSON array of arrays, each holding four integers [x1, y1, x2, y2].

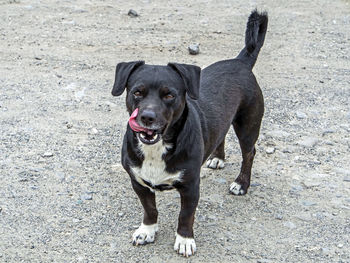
[[168, 63, 201, 100]]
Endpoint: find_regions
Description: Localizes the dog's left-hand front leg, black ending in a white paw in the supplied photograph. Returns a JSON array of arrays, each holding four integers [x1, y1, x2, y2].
[[132, 179, 158, 246]]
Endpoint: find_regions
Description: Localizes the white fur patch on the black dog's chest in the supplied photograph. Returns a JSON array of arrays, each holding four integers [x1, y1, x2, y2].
[[131, 141, 182, 191]]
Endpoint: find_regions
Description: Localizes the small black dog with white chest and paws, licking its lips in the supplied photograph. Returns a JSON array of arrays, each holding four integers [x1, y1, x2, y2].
[[112, 11, 268, 256]]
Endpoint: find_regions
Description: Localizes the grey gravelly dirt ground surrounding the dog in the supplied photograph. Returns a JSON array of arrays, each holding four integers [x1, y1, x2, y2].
[[0, 0, 350, 263]]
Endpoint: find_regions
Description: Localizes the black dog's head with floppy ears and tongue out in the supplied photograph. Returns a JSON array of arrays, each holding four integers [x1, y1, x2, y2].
[[112, 61, 201, 144]]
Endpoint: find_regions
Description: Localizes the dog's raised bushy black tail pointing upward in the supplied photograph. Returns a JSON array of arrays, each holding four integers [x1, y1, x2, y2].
[[237, 9, 268, 68]]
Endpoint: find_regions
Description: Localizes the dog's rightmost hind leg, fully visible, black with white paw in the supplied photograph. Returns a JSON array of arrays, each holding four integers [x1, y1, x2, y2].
[[230, 103, 263, 195]]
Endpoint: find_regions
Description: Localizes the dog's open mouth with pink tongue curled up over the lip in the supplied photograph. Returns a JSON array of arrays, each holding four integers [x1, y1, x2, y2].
[[129, 109, 162, 144]]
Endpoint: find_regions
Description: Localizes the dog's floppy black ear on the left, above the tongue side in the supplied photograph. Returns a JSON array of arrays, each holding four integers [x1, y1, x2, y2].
[[112, 61, 145, 96]]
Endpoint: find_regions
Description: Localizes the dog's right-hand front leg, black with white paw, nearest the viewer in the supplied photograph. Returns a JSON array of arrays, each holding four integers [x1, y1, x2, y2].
[[174, 180, 199, 257]]
